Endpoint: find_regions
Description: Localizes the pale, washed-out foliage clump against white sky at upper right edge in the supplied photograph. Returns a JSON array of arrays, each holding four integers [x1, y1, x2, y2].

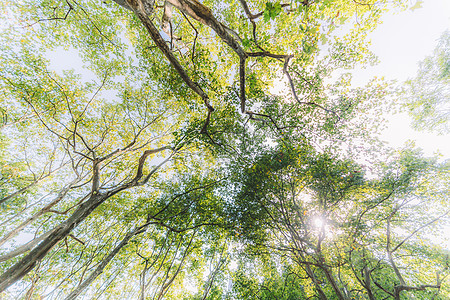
[[401, 31, 450, 134]]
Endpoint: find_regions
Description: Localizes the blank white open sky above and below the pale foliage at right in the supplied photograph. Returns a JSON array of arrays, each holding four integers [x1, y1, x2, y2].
[[354, 0, 450, 158]]
